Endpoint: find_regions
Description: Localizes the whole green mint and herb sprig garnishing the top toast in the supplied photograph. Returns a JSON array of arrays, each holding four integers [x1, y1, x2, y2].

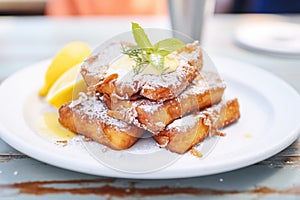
[[123, 22, 185, 74]]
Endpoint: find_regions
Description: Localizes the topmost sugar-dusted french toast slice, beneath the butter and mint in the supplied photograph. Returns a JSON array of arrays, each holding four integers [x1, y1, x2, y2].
[[81, 41, 203, 101]]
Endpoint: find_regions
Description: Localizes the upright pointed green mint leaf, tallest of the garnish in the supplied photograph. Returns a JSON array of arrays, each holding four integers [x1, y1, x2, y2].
[[131, 22, 153, 53]]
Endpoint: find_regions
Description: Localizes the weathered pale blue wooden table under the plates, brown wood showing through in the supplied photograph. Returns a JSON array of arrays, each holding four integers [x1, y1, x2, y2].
[[0, 14, 300, 199]]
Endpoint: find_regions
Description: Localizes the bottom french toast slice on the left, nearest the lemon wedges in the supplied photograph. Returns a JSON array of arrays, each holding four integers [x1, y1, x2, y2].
[[59, 95, 144, 150]]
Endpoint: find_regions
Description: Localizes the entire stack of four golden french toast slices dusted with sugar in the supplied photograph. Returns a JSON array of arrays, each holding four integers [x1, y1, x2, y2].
[[59, 41, 240, 154]]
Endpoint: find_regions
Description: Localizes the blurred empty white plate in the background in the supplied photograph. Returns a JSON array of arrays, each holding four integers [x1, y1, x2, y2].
[[235, 21, 300, 57]]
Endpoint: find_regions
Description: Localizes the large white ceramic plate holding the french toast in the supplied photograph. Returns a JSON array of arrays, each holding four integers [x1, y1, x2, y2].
[[0, 57, 300, 179]]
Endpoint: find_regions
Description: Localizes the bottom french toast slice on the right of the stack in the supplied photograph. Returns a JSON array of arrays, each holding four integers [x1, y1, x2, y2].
[[153, 99, 240, 154]]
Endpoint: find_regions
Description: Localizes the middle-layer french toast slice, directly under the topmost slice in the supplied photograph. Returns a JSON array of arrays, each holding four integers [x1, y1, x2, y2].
[[104, 71, 226, 133]]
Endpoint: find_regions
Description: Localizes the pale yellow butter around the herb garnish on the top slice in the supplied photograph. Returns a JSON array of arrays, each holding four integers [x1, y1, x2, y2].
[[110, 54, 179, 75]]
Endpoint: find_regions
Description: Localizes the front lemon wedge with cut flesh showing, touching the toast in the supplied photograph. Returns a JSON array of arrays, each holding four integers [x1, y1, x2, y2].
[[46, 64, 87, 108]]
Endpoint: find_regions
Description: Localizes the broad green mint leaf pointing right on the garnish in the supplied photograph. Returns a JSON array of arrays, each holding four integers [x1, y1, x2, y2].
[[154, 38, 185, 56]]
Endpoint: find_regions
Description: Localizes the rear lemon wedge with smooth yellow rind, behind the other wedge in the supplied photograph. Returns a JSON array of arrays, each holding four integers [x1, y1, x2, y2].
[[39, 41, 91, 97]]
